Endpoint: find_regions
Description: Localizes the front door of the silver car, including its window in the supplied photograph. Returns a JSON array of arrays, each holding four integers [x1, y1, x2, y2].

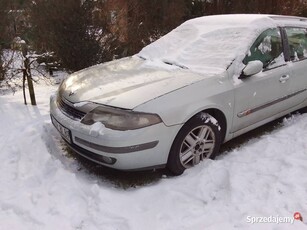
[[232, 28, 294, 132]]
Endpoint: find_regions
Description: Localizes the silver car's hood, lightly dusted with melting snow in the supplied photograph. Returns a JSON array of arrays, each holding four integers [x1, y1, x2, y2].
[[59, 56, 224, 109]]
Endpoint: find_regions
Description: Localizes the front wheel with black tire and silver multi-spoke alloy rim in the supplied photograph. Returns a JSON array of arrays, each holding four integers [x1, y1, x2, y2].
[[167, 113, 222, 175]]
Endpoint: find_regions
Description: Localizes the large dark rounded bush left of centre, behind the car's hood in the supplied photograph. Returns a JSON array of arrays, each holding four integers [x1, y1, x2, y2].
[[30, 0, 102, 71]]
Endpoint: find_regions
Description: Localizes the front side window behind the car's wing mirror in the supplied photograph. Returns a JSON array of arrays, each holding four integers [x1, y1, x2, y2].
[[243, 28, 284, 68]]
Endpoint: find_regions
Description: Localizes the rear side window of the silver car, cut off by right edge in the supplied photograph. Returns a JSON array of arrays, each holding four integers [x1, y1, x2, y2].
[[285, 27, 307, 61]]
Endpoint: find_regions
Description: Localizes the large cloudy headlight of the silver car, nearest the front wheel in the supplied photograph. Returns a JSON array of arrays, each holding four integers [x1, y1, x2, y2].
[[81, 106, 162, 131]]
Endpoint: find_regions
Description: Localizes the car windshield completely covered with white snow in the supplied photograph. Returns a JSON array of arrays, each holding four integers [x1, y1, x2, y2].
[[138, 17, 262, 73]]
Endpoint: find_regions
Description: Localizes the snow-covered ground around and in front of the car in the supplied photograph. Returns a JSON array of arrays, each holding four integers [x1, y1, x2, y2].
[[0, 83, 307, 230]]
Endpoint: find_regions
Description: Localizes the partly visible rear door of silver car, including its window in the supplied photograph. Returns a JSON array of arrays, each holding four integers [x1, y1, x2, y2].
[[285, 27, 307, 105]]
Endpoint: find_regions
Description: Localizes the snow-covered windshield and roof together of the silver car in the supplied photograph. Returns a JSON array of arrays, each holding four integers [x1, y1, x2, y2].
[[138, 14, 306, 73]]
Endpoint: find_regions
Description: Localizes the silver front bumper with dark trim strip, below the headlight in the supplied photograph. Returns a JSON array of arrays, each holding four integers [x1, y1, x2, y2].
[[50, 95, 181, 170]]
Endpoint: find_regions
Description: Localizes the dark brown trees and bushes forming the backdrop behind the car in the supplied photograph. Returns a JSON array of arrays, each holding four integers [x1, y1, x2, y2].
[[15, 0, 306, 70]]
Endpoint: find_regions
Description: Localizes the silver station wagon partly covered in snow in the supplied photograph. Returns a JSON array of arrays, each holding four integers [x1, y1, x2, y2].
[[50, 15, 307, 175]]
